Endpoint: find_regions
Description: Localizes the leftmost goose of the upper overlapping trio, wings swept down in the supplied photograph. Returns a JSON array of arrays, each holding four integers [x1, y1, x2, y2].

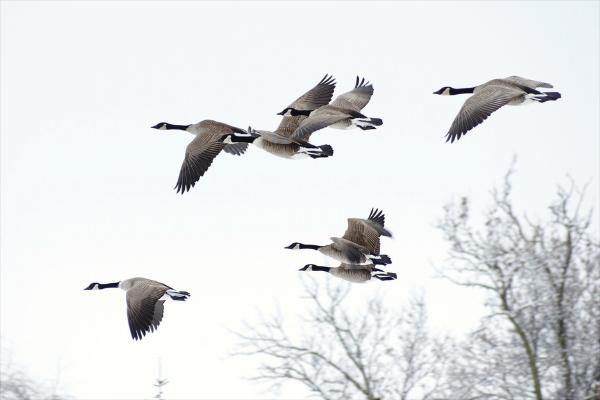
[[152, 119, 254, 194]]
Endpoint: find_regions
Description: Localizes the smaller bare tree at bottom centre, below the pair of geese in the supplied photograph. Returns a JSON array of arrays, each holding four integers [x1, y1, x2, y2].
[[235, 280, 444, 400]]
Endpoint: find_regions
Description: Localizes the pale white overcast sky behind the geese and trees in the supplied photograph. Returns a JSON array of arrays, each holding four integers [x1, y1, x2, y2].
[[0, 1, 600, 399]]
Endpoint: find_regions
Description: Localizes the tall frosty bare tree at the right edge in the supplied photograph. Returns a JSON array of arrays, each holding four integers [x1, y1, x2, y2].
[[439, 168, 600, 400]]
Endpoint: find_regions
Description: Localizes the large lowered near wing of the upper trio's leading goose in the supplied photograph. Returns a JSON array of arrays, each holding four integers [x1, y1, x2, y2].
[[175, 133, 226, 194]]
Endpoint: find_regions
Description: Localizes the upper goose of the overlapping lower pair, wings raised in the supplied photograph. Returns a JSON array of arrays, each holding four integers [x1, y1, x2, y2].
[[285, 209, 392, 265]]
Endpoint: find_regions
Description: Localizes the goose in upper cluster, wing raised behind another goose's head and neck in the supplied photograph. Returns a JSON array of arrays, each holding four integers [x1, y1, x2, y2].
[[248, 75, 335, 158]]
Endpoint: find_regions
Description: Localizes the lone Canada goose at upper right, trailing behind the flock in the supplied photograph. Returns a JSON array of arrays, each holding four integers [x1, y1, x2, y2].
[[433, 76, 561, 143]]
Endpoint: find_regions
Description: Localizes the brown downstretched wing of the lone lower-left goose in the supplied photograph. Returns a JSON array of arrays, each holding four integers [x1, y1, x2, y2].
[[125, 281, 168, 340]]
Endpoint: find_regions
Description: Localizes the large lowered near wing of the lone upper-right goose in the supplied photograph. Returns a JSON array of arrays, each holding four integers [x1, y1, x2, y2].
[[446, 85, 524, 143]]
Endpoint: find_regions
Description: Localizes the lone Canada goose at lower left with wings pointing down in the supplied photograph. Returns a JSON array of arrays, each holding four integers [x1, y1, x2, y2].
[[84, 278, 190, 340]]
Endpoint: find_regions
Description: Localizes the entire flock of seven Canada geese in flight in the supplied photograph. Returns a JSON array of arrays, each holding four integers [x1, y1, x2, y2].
[[85, 75, 561, 340]]
